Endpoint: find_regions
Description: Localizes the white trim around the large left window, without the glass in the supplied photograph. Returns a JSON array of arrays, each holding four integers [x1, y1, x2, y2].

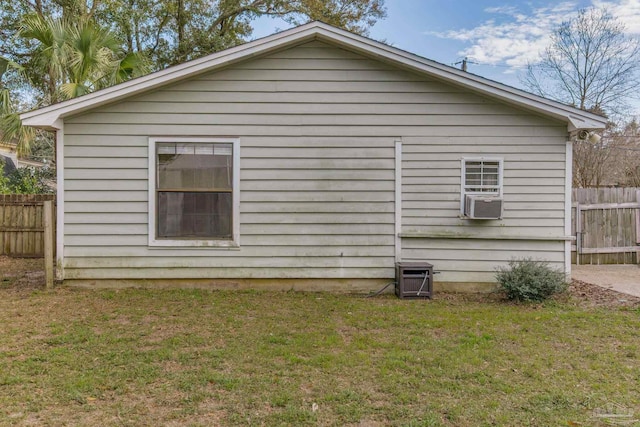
[[148, 136, 240, 249]]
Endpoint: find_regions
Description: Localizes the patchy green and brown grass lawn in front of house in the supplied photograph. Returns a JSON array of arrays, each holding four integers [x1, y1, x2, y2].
[[0, 270, 640, 426]]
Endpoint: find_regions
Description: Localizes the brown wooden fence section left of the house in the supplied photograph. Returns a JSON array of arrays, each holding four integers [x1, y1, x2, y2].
[[0, 194, 55, 257]]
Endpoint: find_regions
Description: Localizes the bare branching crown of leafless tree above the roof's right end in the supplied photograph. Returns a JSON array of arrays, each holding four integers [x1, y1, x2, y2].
[[523, 8, 640, 117]]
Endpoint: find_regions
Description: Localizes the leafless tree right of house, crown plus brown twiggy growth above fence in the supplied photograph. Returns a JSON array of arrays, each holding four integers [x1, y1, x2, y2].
[[523, 8, 640, 187]]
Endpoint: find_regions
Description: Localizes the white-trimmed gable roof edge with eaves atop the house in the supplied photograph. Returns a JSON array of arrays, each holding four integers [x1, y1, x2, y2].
[[20, 22, 607, 131]]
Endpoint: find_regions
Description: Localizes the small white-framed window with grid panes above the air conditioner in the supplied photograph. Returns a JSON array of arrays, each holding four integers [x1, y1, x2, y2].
[[461, 157, 503, 211]]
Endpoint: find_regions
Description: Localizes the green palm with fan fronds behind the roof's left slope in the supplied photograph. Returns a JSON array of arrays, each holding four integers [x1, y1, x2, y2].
[[0, 14, 150, 154]]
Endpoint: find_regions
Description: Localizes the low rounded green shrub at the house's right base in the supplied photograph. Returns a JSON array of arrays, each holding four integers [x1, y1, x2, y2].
[[496, 258, 567, 301]]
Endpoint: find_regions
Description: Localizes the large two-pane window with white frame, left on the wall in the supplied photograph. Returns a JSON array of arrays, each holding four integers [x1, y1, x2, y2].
[[149, 138, 239, 246]]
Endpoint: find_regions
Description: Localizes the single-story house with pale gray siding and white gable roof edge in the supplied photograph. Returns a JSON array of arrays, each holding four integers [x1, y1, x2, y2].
[[21, 22, 606, 290]]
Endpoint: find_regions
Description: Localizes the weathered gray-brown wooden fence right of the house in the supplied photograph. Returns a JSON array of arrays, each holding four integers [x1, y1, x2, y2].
[[571, 188, 640, 264]]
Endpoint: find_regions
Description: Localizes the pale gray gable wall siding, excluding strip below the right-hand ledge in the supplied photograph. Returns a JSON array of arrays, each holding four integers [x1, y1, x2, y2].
[[64, 42, 566, 279]]
